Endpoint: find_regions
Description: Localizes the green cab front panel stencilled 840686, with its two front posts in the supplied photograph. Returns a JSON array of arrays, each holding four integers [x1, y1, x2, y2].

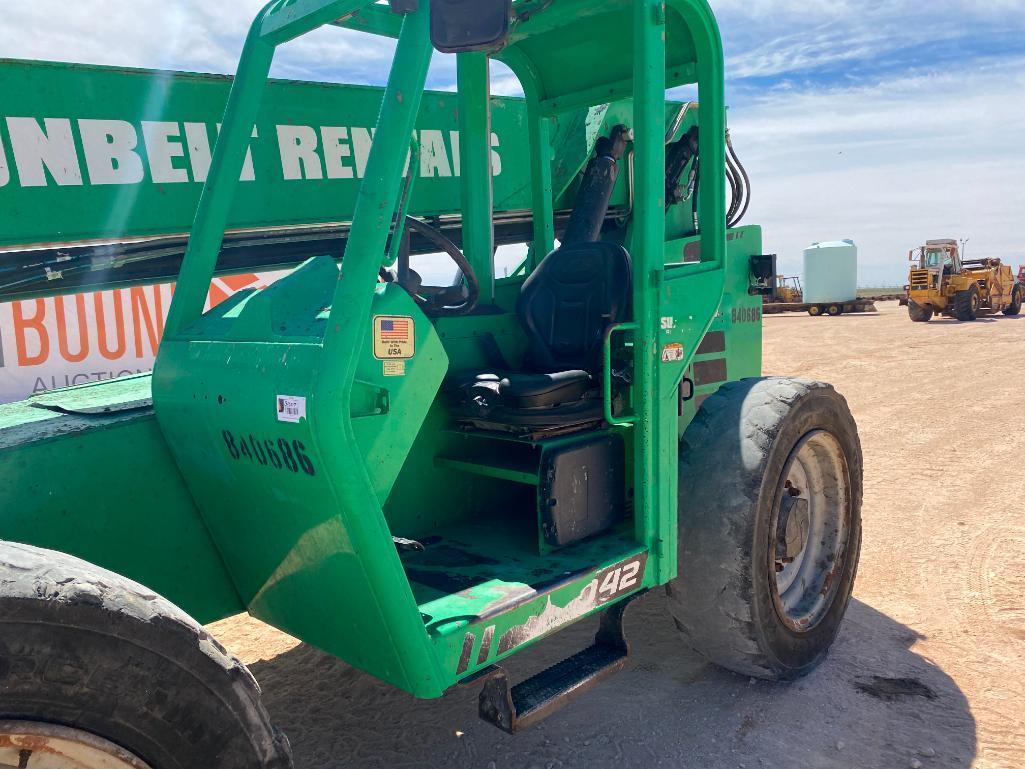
[[154, 3, 447, 696]]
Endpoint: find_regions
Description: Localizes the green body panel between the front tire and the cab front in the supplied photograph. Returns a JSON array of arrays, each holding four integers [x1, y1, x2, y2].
[[0, 375, 245, 622]]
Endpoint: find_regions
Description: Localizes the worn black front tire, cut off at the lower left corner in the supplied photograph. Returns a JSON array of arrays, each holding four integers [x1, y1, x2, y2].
[[0, 541, 292, 769]]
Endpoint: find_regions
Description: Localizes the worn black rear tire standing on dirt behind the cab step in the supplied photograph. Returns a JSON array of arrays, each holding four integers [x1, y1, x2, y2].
[[667, 377, 862, 680]]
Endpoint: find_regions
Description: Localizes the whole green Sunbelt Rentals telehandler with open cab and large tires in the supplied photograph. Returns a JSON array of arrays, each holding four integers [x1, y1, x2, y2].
[[0, 0, 862, 769]]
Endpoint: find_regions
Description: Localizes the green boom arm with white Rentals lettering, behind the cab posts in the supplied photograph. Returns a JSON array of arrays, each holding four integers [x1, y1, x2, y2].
[[0, 59, 630, 301]]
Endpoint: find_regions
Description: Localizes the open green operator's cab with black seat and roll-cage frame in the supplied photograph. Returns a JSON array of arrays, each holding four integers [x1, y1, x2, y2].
[[153, 0, 746, 729]]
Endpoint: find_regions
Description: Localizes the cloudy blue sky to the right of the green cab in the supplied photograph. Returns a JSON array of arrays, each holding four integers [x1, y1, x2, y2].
[[713, 0, 1025, 285]]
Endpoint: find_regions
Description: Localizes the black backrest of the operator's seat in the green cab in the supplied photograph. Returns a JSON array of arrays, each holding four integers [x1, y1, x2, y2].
[[517, 241, 631, 374]]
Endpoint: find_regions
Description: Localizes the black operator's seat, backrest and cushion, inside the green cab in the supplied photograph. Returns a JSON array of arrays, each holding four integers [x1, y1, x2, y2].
[[450, 241, 631, 432]]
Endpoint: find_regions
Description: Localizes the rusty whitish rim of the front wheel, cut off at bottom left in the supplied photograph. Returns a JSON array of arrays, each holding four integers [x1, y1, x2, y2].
[[0, 721, 151, 769]]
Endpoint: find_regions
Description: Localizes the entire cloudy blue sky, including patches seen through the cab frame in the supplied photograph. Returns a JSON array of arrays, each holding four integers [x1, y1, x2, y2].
[[0, 0, 1025, 285]]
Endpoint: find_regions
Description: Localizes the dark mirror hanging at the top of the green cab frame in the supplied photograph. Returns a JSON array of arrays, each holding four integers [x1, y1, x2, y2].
[[431, 0, 513, 53]]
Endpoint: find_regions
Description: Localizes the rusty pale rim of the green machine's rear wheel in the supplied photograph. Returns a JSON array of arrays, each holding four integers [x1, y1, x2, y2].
[[769, 430, 851, 633]]
